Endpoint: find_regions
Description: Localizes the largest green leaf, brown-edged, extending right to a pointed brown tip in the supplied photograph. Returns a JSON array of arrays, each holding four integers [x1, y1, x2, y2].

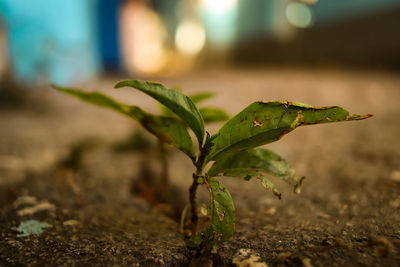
[[206, 101, 372, 162]]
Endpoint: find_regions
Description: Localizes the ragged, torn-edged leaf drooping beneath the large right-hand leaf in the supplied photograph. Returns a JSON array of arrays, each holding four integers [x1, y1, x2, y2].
[[208, 148, 303, 197]]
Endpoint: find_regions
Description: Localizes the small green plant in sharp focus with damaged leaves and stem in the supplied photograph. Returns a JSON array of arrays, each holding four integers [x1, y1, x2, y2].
[[54, 80, 372, 251]]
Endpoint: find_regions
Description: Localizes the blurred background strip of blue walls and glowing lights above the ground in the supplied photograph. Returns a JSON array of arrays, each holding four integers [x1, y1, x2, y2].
[[0, 0, 400, 85]]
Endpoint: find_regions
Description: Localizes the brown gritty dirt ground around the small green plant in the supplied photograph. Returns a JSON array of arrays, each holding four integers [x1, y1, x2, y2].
[[0, 69, 400, 267]]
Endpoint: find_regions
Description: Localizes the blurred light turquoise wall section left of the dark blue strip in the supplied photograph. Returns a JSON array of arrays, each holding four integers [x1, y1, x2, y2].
[[0, 0, 100, 85]]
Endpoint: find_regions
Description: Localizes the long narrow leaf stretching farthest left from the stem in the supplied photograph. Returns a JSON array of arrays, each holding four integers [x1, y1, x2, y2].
[[53, 86, 195, 159]]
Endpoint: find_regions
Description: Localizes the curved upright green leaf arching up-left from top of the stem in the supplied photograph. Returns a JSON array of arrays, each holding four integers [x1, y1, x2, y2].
[[115, 80, 204, 146]]
